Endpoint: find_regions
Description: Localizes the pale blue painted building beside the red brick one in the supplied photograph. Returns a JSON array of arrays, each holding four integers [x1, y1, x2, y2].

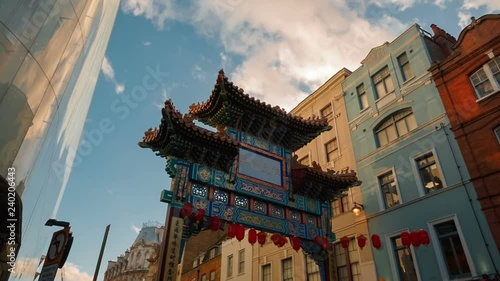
[[342, 25, 500, 281]]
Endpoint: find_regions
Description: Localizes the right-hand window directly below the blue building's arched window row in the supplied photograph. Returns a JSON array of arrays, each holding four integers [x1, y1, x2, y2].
[[415, 152, 443, 193]]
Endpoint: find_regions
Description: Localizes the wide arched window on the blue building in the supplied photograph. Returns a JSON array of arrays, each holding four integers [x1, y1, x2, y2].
[[375, 109, 417, 147]]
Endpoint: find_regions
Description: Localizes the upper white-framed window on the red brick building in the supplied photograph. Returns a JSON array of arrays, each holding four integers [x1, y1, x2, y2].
[[470, 57, 500, 98]]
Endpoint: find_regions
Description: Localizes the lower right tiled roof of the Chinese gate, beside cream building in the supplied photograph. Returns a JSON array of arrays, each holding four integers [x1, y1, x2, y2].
[[292, 155, 360, 202]]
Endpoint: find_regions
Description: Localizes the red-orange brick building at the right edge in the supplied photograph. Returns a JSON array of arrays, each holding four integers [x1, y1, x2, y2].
[[430, 14, 500, 248]]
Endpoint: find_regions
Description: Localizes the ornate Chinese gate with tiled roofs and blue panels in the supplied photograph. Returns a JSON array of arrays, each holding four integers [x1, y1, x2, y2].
[[139, 70, 357, 281]]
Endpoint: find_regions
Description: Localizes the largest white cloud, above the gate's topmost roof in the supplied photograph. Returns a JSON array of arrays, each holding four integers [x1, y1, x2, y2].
[[122, 0, 408, 109]]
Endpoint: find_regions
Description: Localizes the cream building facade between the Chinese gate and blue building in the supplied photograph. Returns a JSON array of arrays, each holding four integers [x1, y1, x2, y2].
[[290, 68, 376, 281]]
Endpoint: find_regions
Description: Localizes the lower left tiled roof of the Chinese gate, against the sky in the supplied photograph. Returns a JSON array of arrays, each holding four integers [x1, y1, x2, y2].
[[139, 100, 239, 172]]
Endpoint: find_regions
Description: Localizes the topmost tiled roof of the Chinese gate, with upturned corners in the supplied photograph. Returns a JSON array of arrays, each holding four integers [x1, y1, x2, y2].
[[189, 70, 331, 151]]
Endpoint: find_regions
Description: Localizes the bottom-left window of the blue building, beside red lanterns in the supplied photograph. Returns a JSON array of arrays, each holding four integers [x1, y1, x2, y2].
[[391, 236, 418, 281]]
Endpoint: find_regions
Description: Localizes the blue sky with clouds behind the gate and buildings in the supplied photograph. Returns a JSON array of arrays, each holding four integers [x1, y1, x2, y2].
[[52, 0, 500, 281]]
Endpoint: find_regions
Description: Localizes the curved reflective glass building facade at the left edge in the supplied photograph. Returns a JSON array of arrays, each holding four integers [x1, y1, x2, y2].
[[0, 0, 120, 281]]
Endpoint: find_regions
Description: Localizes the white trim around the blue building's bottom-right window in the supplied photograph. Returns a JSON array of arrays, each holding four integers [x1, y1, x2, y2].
[[427, 214, 477, 281]]
